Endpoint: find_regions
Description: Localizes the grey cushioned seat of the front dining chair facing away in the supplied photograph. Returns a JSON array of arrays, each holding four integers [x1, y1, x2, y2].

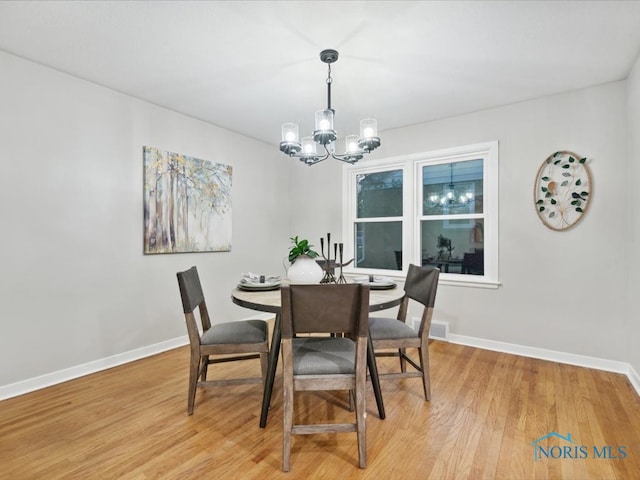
[[293, 337, 356, 375]]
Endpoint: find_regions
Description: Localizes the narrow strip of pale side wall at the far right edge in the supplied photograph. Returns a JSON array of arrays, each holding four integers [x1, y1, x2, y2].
[[627, 57, 640, 378]]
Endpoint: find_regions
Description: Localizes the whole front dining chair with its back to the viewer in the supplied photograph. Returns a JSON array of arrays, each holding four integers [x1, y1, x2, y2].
[[281, 284, 369, 472]]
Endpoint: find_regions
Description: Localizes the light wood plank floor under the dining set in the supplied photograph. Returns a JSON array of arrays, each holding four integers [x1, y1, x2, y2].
[[0, 342, 640, 480]]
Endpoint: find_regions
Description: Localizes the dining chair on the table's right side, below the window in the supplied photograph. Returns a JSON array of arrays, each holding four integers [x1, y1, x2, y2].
[[369, 264, 440, 401]]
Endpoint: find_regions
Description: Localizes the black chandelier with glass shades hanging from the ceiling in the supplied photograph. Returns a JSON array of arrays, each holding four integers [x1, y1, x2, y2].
[[280, 50, 380, 165]]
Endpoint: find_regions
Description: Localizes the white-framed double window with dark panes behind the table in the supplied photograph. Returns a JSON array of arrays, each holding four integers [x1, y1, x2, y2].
[[343, 142, 498, 286]]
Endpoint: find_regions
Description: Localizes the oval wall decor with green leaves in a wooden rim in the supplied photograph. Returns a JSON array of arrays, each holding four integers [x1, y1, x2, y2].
[[533, 150, 592, 230]]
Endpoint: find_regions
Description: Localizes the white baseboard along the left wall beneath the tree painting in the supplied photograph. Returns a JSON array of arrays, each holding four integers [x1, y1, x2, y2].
[[0, 335, 189, 400]]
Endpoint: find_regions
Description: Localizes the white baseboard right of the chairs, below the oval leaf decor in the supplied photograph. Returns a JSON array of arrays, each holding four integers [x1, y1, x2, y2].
[[449, 333, 640, 396]]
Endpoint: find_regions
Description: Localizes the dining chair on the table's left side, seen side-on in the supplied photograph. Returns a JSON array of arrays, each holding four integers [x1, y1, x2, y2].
[[177, 266, 269, 415]]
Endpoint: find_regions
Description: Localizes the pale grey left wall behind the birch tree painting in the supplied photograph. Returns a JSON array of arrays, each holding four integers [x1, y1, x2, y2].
[[0, 52, 289, 387]]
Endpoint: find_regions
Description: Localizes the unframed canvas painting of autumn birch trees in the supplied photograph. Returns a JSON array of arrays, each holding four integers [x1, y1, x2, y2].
[[143, 146, 232, 254]]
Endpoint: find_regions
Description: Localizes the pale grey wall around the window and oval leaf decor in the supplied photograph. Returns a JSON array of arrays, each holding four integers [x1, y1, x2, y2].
[[293, 82, 630, 361]]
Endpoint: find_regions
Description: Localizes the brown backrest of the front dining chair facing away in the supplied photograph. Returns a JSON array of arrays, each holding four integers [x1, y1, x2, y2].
[[281, 284, 369, 338]]
